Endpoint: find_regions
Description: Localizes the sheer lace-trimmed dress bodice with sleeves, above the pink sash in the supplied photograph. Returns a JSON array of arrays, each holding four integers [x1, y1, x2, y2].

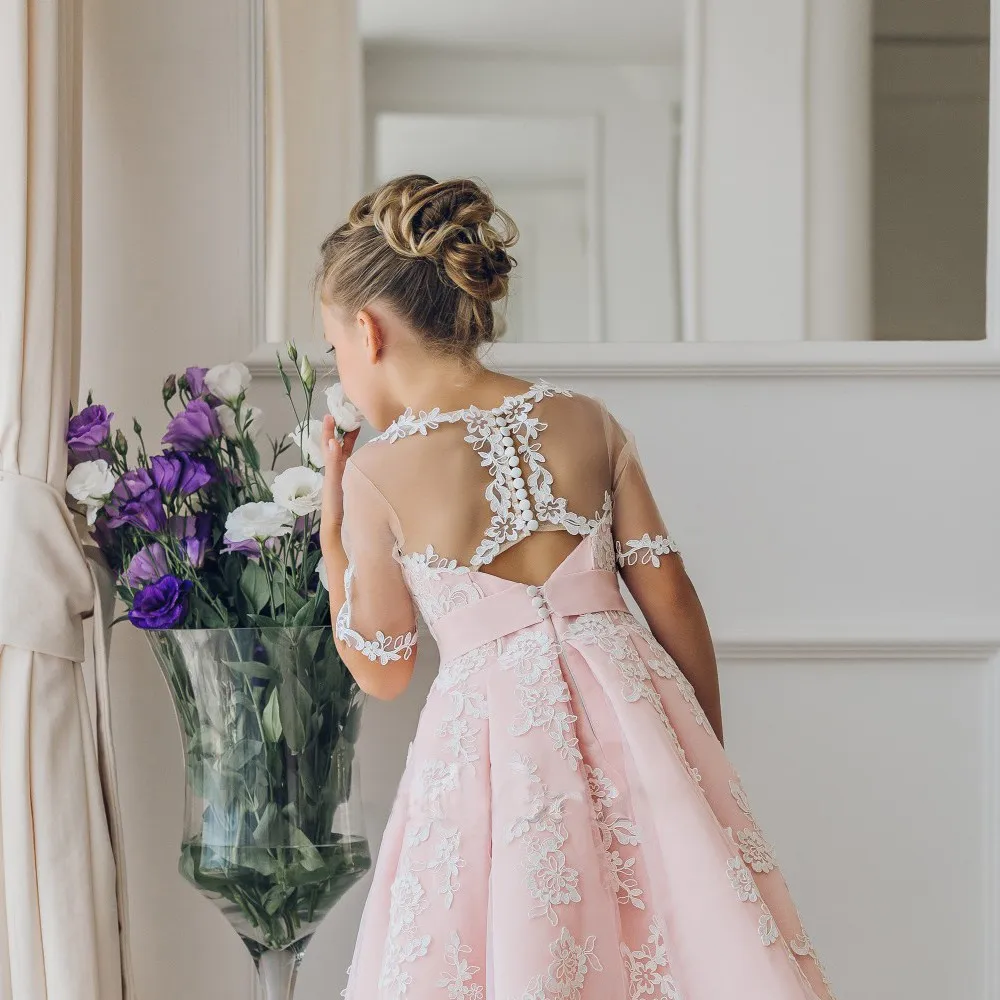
[[337, 381, 677, 664]]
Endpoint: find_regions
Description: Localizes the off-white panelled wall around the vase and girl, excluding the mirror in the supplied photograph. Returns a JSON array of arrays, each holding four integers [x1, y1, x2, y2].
[[83, 0, 1000, 1000]]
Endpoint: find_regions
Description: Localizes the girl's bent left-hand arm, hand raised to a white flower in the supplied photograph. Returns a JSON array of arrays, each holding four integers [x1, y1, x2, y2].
[[320, 416, 417, 699]]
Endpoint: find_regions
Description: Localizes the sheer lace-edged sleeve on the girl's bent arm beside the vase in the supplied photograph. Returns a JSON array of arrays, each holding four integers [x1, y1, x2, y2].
[[336, 461, 417, 666]]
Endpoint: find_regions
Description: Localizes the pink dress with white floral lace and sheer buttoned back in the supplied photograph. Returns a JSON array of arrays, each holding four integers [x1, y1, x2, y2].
[[337, 382, 832, 1000]]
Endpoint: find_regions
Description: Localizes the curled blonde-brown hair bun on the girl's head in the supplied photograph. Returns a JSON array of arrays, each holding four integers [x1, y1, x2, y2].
[[366, 174, 518, 302]]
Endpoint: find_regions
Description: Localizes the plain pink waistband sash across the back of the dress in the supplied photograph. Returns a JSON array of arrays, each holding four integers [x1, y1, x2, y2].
[[433, 569, 628, 663]]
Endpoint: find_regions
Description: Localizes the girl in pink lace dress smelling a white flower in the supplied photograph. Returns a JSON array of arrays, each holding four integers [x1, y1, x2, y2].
[[320, 175, 831, 1000]]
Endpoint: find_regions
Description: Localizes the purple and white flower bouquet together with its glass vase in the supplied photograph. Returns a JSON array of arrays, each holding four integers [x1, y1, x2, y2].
[[66, 345, 371, 1000]]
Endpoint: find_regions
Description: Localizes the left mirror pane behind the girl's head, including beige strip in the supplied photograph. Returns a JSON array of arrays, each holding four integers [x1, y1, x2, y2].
[[262, 0, 684, 354]]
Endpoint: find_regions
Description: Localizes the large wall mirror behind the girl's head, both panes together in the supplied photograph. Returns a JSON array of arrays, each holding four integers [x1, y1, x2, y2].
[[254, 0, 990, 356]]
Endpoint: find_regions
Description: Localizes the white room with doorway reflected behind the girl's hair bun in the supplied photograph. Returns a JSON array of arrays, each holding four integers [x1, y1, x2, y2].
[[360, 0, 684, 341]]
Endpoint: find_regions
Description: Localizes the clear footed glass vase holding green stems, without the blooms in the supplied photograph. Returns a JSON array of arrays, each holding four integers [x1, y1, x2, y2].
[[148, 627, 371, 1000]]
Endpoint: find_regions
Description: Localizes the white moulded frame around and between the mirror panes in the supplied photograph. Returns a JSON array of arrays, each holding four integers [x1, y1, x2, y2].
[[247, 0, 1000, 378]]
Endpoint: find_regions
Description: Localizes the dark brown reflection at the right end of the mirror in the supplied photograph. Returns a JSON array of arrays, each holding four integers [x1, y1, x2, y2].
[[872, 0, 990, 340]]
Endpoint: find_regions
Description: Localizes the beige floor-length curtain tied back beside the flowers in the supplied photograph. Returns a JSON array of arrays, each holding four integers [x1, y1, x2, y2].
[[0, 0, 130, 1000]]
